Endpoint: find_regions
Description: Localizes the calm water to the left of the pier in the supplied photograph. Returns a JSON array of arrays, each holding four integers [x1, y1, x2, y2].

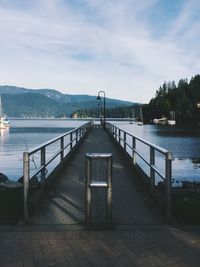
[[0, 119, 88, 180]]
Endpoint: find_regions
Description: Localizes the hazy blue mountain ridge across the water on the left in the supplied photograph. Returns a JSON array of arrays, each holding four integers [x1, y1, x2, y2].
[[0, 85, 135, 117]]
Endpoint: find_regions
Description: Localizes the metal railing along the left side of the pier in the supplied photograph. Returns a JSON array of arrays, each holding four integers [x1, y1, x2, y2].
[[23, 122, 91, 222]]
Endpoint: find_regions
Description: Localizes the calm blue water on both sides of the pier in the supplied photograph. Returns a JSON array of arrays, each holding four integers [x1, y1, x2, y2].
[[0, 119, 200, 186]]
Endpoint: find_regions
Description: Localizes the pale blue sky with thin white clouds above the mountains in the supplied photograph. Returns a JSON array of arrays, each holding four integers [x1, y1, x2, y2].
[[0, 0, 200, 103]]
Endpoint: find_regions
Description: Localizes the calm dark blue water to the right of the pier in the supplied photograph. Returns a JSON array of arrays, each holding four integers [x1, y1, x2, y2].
[[114, 122, 200, 186]]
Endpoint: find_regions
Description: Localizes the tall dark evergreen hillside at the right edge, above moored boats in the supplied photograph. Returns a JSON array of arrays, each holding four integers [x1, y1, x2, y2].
[[143, 75, 200, 124]]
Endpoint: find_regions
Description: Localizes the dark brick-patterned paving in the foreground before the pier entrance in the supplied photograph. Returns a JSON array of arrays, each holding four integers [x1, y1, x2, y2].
[[0, 226, 200, 267]]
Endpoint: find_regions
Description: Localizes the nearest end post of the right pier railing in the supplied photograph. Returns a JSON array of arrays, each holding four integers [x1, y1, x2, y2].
[[165, 152, 172, 219]]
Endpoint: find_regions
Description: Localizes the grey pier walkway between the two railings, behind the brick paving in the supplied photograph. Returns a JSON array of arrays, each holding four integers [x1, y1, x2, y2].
[[32, 127, 163, 227]]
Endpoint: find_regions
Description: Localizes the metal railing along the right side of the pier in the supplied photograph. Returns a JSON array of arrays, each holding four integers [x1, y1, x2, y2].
[[106, 122, 172, 218]]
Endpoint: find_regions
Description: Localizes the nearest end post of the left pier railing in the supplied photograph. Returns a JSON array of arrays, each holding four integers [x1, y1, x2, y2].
[[23, 152, 30, 223]]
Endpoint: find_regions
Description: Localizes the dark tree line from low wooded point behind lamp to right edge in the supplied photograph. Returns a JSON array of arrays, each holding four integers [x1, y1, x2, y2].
[[72, 75, 200, 125]]
